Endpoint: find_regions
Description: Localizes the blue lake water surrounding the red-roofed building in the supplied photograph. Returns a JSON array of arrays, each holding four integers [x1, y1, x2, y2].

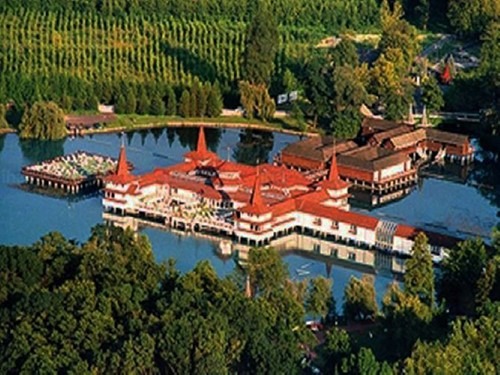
[[0, 128, 500, 305]]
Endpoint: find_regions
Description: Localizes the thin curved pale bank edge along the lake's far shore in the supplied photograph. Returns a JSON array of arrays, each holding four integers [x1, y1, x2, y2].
[[80, 121, 320, 137]]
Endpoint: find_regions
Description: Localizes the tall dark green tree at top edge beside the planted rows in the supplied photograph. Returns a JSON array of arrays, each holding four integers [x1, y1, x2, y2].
[[242, 0, 279, 86]]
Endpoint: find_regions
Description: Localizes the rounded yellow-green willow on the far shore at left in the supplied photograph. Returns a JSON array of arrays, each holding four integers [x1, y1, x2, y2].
[[19, 102, 67, 140]]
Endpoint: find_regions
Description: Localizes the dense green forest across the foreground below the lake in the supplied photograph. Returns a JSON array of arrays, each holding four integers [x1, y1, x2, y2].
[[0, 225, 500, 374]]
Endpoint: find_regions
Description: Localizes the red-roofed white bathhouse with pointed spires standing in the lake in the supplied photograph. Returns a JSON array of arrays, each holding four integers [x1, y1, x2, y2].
[[103, 129, 455, 263]]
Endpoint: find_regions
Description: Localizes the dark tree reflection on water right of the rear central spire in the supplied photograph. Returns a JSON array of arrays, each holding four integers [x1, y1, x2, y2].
[[233, 129, 274, 165]]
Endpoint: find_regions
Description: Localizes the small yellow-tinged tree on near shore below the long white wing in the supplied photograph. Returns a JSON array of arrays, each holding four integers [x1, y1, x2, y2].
[[343, 275, 378, 320]]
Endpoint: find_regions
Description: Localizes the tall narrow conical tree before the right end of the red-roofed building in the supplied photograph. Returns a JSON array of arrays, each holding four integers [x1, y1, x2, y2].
[[404, 232, 434, 309]]
